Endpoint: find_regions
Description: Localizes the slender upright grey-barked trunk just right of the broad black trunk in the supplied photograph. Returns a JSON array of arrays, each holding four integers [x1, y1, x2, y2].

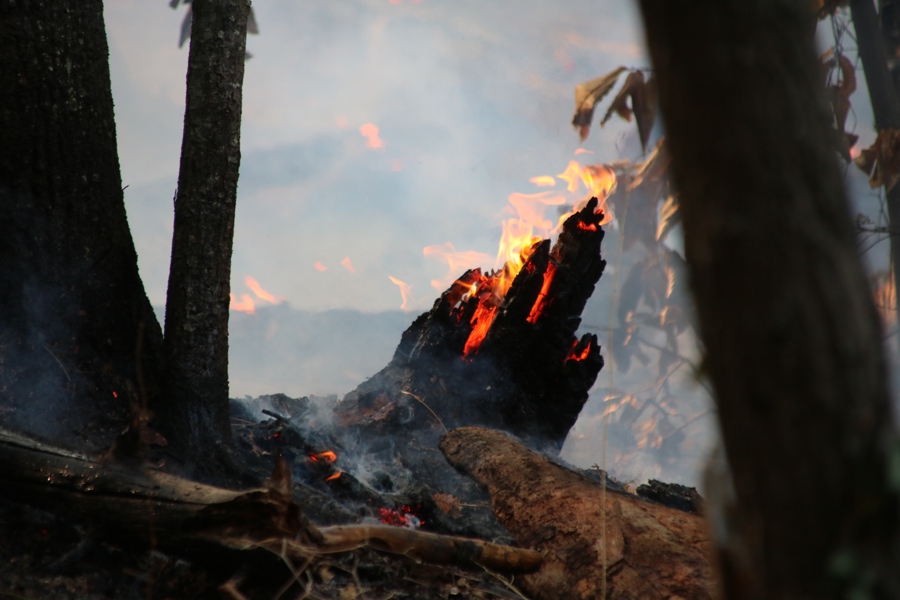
[[158, 0, 250, 452]]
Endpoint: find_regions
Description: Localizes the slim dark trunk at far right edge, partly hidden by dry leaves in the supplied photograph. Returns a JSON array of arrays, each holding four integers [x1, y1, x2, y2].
[[850, 0, 900, 336]]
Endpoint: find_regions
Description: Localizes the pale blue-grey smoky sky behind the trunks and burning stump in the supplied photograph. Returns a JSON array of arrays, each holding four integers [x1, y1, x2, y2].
[[105, 0, 885, 483]]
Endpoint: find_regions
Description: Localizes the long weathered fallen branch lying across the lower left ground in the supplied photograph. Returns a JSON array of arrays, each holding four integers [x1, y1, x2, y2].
[[0, 430, 541, 572]]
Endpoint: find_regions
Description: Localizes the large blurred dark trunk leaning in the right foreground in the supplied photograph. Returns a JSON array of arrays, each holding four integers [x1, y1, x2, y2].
[[641, 0, 900, 598]]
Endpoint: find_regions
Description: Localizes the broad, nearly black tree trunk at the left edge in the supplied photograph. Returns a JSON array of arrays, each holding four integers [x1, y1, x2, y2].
[[0, 0, 162, 446]]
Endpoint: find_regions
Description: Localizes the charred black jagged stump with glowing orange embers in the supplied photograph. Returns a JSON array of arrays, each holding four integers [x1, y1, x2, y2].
[[339, 198, 606, 448]]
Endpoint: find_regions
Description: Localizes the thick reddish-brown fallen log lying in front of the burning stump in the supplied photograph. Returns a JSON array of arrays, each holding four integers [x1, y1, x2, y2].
[[440, 427, 716, 600]]
